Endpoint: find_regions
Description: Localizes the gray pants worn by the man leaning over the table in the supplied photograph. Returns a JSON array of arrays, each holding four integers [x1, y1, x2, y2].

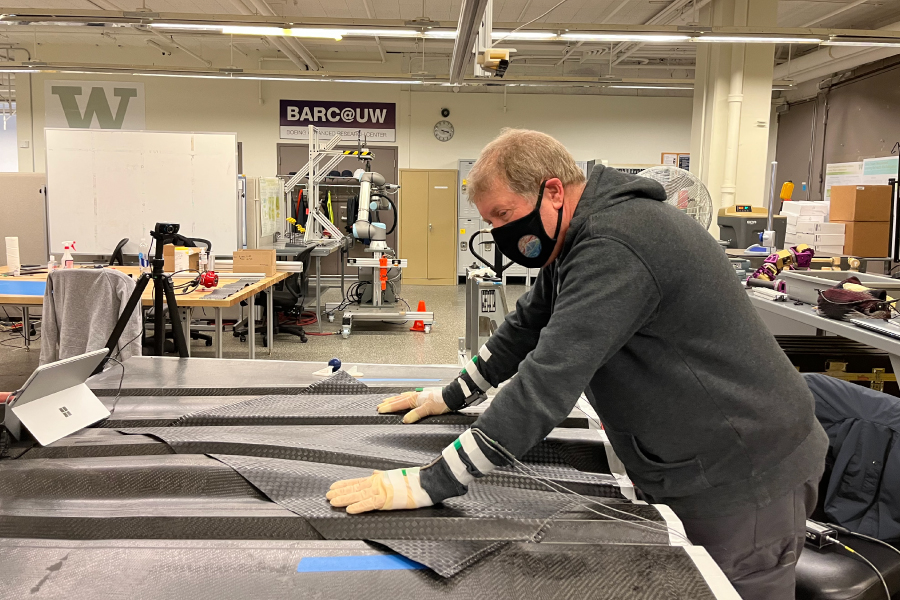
[[682, 477, 819, 600]]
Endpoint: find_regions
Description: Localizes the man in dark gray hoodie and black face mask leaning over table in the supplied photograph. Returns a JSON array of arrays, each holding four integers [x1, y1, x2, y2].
[[328, 130, 828, 600]]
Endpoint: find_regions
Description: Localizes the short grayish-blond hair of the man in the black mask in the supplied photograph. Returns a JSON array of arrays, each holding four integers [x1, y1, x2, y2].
[[467, 129, 584, 203]]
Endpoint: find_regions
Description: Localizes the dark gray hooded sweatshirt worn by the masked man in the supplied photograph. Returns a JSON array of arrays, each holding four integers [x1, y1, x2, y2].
[[421, 166, 828, 518]]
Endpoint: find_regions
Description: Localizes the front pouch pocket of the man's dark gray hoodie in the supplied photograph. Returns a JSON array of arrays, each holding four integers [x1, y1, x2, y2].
[[604, 425, 712, 498]]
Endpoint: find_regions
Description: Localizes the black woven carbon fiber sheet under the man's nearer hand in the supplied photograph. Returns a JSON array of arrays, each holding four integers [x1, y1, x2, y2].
[[212, 455, 659, 577]]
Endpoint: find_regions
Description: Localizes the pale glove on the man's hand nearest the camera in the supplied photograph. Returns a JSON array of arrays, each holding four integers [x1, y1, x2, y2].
[[325, 467, 434, 515]]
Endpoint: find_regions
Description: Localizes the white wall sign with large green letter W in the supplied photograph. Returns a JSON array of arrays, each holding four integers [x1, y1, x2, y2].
[[44, 81, 144, 129]]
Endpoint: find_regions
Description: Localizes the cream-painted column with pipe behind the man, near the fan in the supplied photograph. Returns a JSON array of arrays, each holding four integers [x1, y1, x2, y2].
[[691, 0, 778, 223]]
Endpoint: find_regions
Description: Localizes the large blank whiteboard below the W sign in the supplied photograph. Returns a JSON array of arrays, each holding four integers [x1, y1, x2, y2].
[[44, 128, 240, 254]]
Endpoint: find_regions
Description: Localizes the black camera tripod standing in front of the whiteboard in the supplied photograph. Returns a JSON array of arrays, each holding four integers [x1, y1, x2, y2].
[[92, 223, 189, 375]]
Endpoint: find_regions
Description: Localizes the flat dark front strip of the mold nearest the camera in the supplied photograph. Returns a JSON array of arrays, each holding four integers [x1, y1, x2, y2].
[[0, 540, 716, 600]]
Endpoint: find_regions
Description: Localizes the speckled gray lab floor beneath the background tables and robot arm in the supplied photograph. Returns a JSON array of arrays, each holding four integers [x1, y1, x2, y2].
[[0, 285, 526, 391]]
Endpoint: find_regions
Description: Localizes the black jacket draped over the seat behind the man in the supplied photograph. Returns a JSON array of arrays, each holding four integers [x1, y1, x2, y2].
[[805, 374, 900, 541]]
